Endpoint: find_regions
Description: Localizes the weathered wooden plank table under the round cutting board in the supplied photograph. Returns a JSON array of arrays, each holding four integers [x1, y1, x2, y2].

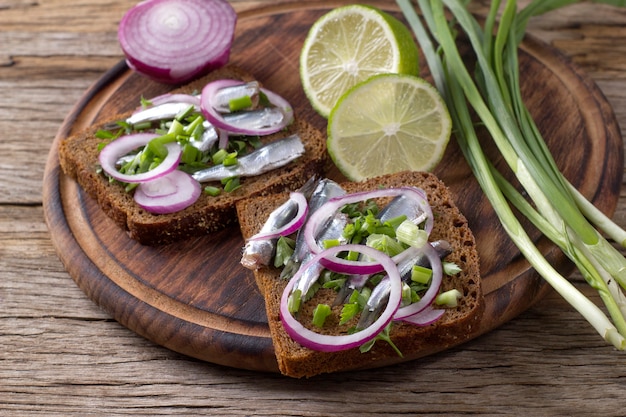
[[0, 0, 626, 416]]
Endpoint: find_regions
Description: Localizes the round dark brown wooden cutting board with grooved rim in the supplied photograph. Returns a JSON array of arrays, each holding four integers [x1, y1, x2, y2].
[[44, 2, 623, 371]]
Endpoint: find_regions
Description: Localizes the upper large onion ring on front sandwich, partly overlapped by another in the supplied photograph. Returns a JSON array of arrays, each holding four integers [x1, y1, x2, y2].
[[304, 187, 434, 274]]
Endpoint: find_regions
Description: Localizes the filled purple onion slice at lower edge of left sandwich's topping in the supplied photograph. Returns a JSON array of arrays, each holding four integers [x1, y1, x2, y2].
[[134, 170, 202, 214]]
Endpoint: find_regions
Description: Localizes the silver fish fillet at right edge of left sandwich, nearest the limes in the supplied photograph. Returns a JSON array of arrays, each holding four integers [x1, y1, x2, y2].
[[192, 135, 304, 182]]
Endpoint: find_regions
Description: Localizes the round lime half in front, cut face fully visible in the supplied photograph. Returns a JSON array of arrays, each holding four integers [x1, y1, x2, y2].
[[327, 74, 452, 181]]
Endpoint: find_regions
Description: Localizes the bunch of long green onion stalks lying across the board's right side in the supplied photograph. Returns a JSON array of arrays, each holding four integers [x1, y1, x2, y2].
[[397, 0, 626, 350]]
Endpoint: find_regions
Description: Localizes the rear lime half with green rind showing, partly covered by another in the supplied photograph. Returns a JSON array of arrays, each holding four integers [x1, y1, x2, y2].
[[300, 4, 419, 118]]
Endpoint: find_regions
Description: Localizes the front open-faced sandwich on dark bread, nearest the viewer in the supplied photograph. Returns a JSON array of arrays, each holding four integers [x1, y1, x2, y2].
[[237, 172, 484, 377]]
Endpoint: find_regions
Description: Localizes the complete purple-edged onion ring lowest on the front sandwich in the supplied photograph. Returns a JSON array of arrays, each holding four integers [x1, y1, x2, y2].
[[280, 245, 402, 352]]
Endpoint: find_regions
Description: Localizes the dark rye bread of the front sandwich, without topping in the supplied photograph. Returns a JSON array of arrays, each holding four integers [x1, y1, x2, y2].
[[237, 172, 484, 378]]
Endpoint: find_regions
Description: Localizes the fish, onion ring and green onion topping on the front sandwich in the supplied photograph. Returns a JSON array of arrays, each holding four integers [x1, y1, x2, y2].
[[241, 179, 461, 354]]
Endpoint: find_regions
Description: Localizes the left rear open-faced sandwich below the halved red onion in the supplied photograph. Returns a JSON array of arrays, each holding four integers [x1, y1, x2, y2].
[[59, 66, 327, 245]]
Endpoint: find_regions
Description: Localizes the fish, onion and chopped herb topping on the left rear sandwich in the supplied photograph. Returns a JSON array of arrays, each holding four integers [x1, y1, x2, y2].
[[98, 79, 304, 214]]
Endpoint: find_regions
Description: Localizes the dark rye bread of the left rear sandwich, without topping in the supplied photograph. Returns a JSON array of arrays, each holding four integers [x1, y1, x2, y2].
[[59, 67, 327, 245]]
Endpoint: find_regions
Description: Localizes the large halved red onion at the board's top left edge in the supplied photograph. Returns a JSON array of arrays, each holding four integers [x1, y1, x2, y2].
[[118, 0, 237, 84]]
